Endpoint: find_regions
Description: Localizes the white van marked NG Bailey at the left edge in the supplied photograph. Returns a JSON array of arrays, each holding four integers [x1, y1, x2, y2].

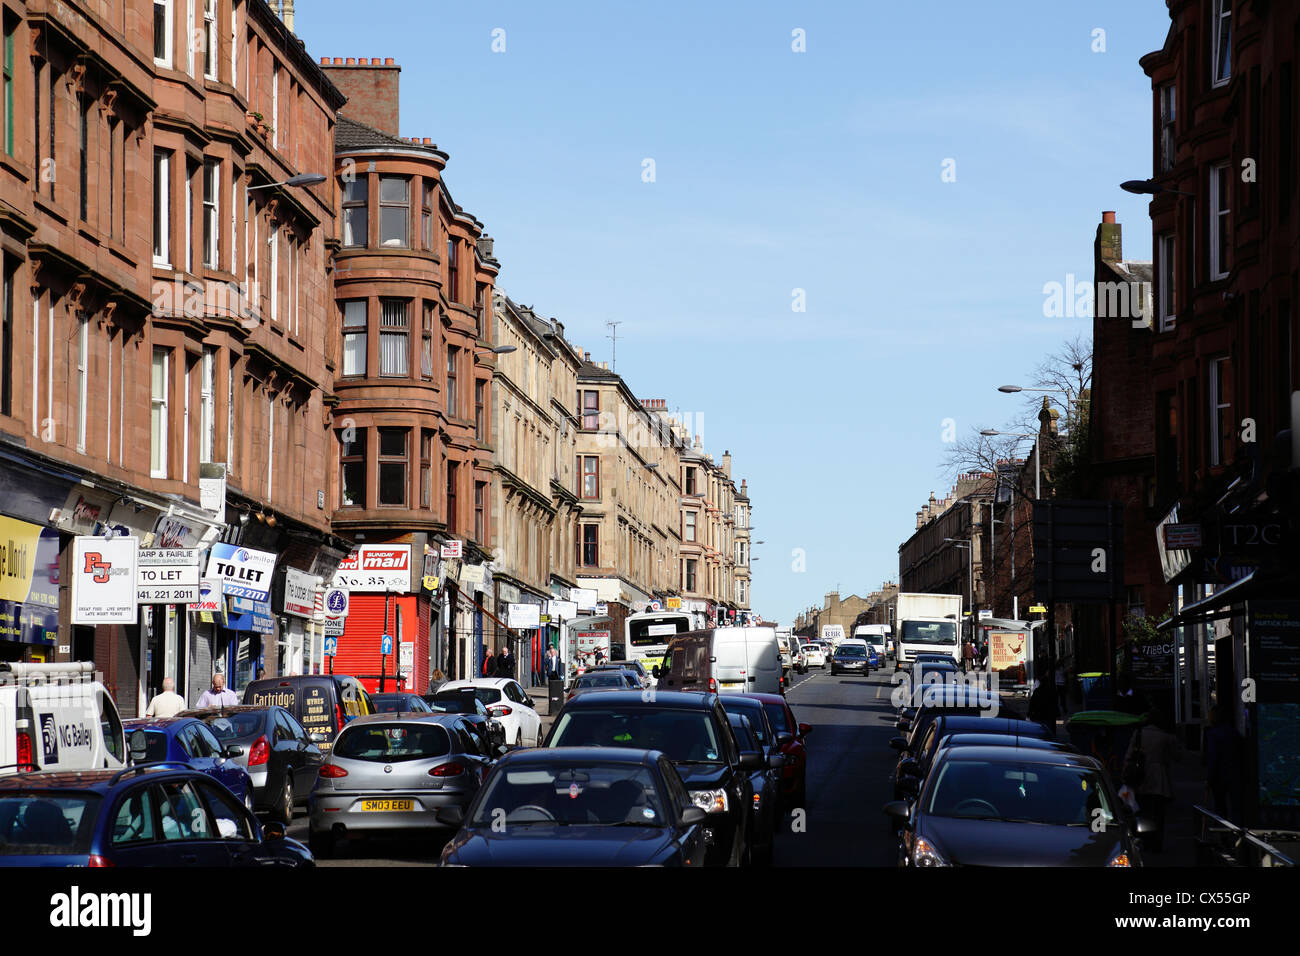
[[0, 661, 126, 774]]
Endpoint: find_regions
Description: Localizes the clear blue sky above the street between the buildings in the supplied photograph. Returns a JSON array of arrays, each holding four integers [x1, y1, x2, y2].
[[296, 0, 1169, 623]]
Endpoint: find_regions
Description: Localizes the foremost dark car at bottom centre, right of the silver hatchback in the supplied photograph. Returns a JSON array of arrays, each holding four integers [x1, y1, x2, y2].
[[438, 747, 709, 866]]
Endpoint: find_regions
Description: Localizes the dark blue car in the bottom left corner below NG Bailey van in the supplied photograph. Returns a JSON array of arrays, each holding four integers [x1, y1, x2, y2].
[[0, 763, 316, 866]]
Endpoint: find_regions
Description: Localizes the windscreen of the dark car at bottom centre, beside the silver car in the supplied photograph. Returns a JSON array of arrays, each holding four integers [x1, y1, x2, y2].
[[469, 762, 668, 832]]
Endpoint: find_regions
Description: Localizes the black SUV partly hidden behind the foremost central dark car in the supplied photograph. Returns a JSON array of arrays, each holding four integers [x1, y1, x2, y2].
[[545, 691, 762, 866]]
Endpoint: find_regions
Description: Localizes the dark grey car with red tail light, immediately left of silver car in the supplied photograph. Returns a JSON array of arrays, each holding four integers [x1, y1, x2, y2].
[[177, 704, 325, 825]]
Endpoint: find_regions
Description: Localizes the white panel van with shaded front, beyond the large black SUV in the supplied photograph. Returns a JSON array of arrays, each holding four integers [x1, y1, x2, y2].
[[658, 627, 784, 693]]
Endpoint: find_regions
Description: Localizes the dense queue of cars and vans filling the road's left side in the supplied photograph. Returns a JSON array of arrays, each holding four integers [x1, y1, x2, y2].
[[0, 627, 813, 866]]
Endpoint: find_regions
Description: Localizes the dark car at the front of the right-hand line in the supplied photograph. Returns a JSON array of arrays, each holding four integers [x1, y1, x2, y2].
[[884, 747, 1147, 866]]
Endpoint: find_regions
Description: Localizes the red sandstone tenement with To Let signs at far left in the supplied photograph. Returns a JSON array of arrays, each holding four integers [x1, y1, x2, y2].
[[0, 0, 348, 715]]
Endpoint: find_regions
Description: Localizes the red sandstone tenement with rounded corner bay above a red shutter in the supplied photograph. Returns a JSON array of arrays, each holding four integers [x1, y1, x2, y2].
[[321, 57, 504, 691]]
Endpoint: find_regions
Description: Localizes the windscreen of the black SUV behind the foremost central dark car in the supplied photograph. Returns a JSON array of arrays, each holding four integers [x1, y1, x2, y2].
[[550, 706, 725, 763]]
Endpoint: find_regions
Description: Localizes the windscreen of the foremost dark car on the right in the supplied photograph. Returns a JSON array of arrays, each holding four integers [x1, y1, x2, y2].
[[926, 760, 1115, 826]]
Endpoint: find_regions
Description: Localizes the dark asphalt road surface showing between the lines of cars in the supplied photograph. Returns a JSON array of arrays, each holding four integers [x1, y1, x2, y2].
[[289, 666, 898, 866]]
